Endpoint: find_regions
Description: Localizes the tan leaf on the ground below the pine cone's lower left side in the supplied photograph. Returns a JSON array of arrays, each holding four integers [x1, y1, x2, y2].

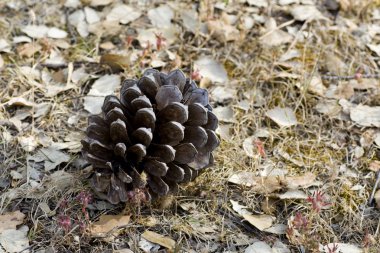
[[90, 214, 131, 237]]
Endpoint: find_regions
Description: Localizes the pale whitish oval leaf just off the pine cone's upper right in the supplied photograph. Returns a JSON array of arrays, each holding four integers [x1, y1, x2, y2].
[[194, 57, 228, 83]]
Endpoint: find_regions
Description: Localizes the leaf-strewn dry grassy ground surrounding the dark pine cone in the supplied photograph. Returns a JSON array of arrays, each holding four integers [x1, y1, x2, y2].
[[0, 0, 380, 253]]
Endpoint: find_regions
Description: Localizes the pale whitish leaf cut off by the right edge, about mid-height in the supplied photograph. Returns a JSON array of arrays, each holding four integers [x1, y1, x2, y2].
[[350, 105, 380, 127]]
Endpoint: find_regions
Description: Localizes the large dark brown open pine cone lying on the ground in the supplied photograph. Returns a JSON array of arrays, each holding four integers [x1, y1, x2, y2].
[[82, 69, 219, 204]]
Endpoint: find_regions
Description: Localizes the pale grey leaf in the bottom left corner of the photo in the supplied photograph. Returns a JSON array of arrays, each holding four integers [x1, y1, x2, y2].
[[0, 226, 30, 253]]
